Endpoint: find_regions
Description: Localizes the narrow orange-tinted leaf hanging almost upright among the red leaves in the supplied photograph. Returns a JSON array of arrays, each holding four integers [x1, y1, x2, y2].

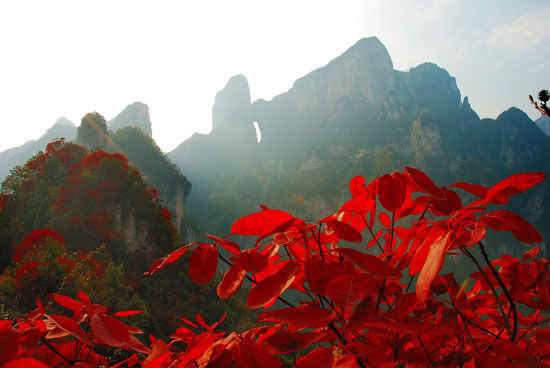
[[416, 233, 449, 303]]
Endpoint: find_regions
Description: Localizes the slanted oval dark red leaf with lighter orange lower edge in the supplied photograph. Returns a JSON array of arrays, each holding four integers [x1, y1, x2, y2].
[[246, 262, 301, 309]]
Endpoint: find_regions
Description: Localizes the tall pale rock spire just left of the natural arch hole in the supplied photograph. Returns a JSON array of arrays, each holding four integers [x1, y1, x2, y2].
[[212, 74, 256, 141]]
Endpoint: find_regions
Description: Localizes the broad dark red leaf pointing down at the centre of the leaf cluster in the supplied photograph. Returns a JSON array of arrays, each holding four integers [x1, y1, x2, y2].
[[327, 273, 376, 312]]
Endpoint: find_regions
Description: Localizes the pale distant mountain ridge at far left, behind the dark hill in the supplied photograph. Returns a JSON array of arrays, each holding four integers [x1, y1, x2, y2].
[[0, 117, 77, 181]]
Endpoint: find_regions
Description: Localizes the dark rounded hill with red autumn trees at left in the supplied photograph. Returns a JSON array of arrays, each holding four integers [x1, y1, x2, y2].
[[0, 140, 249, 340]]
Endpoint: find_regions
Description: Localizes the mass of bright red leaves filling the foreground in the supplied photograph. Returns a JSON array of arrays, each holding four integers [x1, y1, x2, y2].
[[5, 168, 550, 368]]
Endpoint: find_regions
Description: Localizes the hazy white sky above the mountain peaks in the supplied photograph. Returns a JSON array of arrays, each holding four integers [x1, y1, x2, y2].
[[0, 0, 550, 151]]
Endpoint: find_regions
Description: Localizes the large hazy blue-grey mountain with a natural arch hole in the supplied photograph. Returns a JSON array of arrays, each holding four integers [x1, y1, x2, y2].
[[168, 37, 550, 250]]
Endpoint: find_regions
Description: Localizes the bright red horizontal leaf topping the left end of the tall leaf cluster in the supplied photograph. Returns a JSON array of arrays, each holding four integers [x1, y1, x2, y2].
[[231, 209, 294, 236]]
